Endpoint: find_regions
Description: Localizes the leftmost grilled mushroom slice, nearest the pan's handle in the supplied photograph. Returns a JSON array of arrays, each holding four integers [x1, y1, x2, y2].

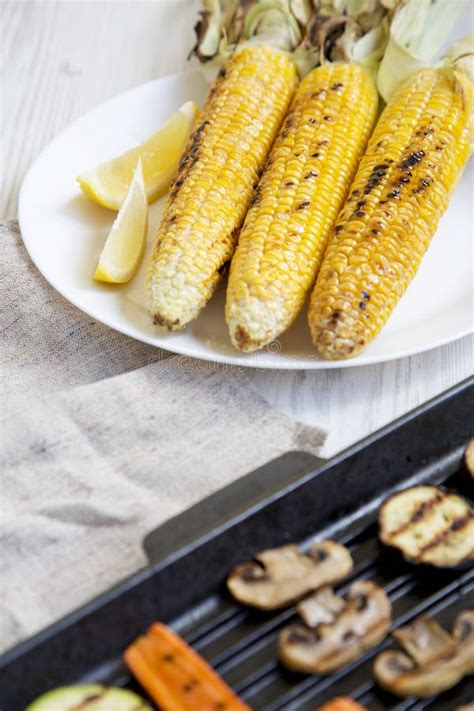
[[227, 541, 354, 610]]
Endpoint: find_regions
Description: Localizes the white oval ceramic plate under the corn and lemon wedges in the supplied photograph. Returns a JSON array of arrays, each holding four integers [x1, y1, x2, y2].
[[19, 71, 473, 369]]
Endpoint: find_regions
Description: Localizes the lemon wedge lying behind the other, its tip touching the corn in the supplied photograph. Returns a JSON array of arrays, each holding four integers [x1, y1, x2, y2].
[[77, 101, 199, 210]]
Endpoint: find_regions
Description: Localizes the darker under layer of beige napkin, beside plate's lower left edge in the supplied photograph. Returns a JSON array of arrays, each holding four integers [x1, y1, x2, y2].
[[0, 220, 170, 408]]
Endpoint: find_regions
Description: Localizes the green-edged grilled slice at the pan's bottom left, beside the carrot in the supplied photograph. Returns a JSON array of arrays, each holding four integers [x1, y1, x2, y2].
[[26, 684, 152, 711]]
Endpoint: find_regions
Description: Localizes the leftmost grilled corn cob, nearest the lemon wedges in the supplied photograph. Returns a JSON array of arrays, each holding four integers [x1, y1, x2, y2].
[[146, 46, 297, 330]]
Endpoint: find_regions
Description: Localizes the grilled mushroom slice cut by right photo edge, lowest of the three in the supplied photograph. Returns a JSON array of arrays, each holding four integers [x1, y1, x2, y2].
[[374, 610, 474, 698]]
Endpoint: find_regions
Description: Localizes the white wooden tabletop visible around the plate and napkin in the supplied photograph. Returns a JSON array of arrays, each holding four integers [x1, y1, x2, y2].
[[4, 0, 474, 456]]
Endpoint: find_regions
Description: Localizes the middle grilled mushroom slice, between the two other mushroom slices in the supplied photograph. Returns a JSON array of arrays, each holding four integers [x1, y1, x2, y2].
[[278, 580, 391, 674]]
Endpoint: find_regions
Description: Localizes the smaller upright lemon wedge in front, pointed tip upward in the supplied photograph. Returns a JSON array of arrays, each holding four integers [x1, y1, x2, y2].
[[94, 159, 148, 284]]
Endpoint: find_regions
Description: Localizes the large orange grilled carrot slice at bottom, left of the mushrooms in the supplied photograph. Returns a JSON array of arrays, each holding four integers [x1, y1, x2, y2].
[[124, 623, 251, 711]]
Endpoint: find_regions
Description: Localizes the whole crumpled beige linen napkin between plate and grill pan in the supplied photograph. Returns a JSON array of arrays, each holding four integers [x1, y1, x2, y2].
[[0, 222, 324, 649]]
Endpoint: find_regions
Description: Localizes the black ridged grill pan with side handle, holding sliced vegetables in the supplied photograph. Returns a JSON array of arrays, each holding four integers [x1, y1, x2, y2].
[[0, 379, 474, 711]]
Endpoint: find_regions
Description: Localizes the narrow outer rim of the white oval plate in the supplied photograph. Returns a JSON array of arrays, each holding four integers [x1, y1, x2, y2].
[[18, 67, 474, 371]]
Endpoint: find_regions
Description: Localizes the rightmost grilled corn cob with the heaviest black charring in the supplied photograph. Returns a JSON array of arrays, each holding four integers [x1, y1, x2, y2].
[[309, 69, 471, 359]]
